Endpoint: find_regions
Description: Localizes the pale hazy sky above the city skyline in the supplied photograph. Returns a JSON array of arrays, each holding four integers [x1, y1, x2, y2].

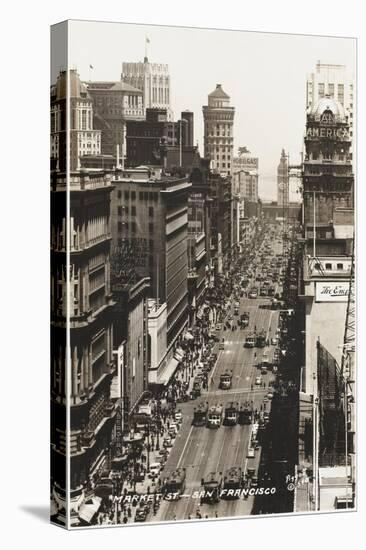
[[64, 21, 356, 203]]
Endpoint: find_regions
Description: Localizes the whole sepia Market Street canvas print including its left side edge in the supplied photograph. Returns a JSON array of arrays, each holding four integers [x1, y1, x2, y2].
[[50, 20, 357, 529]]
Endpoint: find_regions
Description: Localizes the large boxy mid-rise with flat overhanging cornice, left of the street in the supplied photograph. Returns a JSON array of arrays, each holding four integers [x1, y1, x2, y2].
[[112, 167, 192, 347]]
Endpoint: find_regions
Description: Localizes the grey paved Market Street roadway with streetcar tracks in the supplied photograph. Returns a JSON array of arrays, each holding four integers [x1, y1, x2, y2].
[[150, 235, 280, 521]]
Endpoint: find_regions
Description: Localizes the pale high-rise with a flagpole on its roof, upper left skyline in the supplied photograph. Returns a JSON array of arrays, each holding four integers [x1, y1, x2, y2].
[[121, 57, 173, 120]]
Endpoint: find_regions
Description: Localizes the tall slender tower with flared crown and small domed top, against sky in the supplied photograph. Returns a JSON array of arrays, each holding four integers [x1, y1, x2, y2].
[[202, 84, 235, 174]]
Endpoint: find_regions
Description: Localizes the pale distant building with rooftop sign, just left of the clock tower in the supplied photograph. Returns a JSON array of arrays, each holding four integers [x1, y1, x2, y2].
[[232, 147, 259, 202]]
